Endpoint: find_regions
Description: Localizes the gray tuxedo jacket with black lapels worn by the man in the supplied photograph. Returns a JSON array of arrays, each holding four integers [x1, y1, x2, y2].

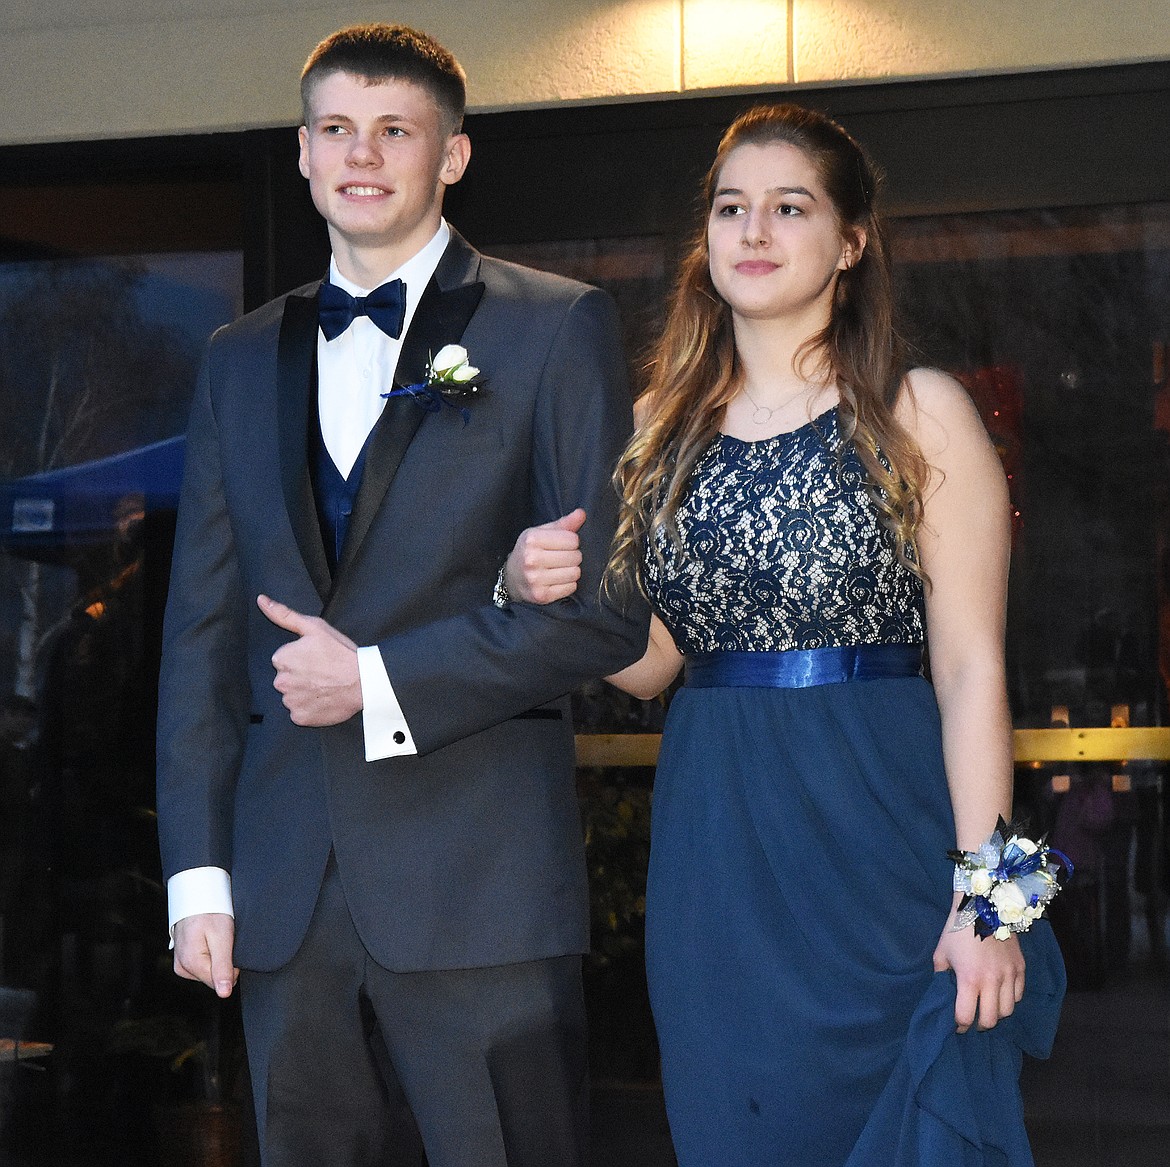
[[158, 233, 647, 970]]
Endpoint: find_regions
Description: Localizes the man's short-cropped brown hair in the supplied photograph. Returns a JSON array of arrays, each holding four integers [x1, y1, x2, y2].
[[301, 23, 467, 132]]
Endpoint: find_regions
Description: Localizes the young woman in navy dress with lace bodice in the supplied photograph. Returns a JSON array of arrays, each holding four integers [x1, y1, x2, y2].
[[507, 105, 1064, 1167]]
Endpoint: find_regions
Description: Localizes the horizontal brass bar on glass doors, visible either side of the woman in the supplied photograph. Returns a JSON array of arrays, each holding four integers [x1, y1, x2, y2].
[[577, 726, 1170, 767]]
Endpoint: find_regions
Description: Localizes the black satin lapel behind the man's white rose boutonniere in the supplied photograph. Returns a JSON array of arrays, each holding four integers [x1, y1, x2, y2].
[[337, 273, 483, 577]]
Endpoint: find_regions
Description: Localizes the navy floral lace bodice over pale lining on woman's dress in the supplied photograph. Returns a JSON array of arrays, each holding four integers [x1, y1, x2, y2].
[[646, 409, 923, 653]]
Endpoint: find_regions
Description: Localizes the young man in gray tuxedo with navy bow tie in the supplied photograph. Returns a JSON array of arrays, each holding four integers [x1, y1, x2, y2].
[[158, 25, 646, 1167]]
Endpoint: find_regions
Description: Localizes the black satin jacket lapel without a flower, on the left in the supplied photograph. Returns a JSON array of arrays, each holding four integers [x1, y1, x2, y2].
[[276, 296, 332, 599]]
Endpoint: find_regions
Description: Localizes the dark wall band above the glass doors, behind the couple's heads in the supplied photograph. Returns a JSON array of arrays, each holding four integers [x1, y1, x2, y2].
[[0, 62, 1170, 307]]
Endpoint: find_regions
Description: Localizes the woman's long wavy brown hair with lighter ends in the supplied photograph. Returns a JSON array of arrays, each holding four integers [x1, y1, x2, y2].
[[608, 104, 928, 586]]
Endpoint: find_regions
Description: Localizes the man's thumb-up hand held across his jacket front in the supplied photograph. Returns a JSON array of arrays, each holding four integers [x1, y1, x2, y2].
[[256, 596, 362, 726]]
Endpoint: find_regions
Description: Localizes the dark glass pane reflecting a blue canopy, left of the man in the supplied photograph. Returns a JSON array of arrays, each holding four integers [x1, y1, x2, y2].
[[0, 245, 242, 1163]]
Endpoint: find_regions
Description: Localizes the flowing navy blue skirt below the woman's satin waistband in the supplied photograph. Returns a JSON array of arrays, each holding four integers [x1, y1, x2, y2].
[[647, 677, 1065, 1167]]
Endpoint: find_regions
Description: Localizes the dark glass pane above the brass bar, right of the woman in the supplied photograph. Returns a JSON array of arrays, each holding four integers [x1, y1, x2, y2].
[[894, 204, 1170, 726]]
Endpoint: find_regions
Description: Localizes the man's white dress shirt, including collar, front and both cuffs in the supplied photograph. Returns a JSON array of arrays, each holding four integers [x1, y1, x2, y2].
[[166, 220, 450, 936]]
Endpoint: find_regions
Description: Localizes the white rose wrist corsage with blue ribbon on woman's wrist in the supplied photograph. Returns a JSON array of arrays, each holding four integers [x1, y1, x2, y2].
[[947, 817, 1073, 940]]
